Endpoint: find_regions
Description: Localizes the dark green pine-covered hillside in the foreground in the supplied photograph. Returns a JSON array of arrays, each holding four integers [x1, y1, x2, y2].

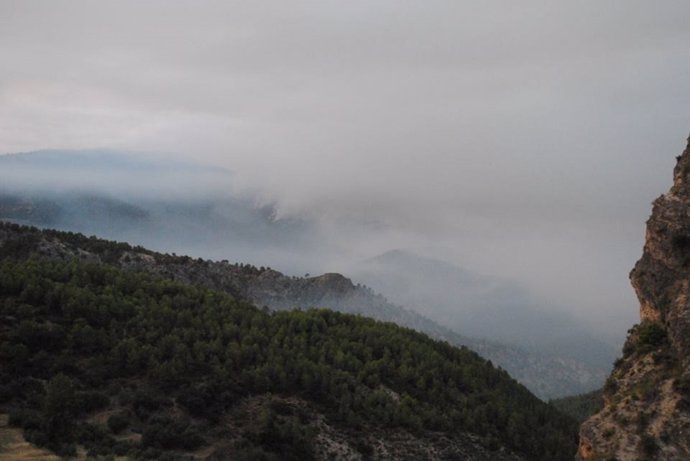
[[0, 224, 576, 461]]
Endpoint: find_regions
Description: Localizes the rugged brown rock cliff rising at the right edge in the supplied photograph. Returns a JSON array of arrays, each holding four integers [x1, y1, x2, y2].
[[578, 138, 690, 461]]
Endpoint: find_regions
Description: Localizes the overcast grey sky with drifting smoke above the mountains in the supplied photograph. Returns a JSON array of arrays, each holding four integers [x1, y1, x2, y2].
[[0, 0, 690, 335]]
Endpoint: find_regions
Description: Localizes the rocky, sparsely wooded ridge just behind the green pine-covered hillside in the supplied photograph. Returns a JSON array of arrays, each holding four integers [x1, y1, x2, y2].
[[0, 223, 601, 399]]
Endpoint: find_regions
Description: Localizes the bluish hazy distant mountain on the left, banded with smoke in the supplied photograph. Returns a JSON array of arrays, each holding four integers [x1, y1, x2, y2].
[[0, 150, 314, 273]]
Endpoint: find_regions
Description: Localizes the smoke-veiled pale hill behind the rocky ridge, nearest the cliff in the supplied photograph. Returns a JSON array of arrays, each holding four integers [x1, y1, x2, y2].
[[350, 250, 616, 386]]
